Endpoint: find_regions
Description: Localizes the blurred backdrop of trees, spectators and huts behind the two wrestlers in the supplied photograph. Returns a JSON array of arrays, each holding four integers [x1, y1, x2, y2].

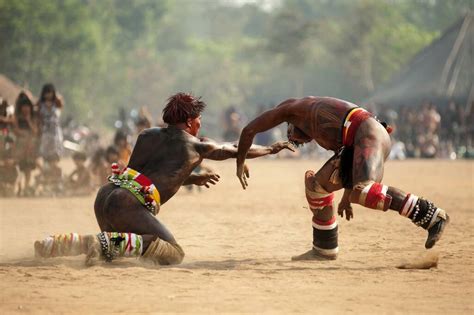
[[0, 0, 474, 195]]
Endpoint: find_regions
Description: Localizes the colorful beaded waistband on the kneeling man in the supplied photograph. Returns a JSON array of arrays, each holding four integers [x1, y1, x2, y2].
[[109, 163, 161, 215]]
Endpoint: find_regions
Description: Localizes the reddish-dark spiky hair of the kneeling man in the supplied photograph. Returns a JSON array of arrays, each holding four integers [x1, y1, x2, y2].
[[163, 92, 206, 125]]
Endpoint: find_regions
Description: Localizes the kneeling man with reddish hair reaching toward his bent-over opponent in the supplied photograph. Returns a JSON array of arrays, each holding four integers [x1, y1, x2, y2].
[[35, 93, 292, 265]]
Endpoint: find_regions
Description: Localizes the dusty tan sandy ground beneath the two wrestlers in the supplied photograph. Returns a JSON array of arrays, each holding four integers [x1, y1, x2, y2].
[[0, 160, 474, 314]]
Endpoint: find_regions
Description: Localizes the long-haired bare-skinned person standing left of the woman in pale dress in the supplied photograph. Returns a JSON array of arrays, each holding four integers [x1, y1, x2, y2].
[[13, 92, 38, 196]]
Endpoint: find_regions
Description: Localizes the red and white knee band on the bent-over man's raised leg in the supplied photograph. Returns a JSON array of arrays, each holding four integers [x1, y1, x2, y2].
[[349, 181, 392, 211]]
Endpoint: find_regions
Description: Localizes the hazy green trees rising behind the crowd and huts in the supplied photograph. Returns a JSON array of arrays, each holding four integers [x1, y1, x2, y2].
[[0, 0, 472, 128]]
